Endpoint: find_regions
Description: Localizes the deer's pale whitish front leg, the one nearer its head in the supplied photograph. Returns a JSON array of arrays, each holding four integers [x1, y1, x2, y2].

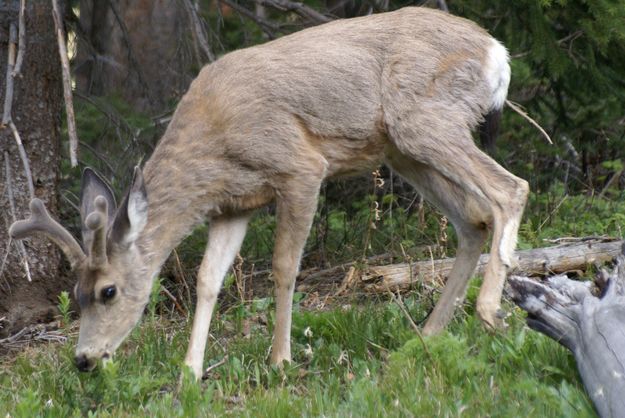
[[184, 216, 249, 379]]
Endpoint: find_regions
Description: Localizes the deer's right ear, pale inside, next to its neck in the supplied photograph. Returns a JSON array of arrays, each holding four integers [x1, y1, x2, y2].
[[108, 166, 148, 248]]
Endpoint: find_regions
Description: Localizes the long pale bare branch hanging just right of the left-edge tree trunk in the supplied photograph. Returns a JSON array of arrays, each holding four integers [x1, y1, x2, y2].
[[52, 0, 78, 167]]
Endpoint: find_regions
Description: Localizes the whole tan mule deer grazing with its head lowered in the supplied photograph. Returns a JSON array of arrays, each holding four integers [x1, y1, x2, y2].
[[11, 7, 528, 377]]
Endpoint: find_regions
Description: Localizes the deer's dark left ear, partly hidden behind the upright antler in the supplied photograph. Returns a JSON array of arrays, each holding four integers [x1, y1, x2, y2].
[[80, 167, 117, 249]]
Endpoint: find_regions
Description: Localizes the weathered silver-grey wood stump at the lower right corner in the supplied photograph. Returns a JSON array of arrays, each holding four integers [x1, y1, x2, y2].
[[508, 254, 625, 417]]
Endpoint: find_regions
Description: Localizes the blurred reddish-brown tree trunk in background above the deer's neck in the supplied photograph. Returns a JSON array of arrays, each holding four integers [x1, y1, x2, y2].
[[74, 0, 199, 112]]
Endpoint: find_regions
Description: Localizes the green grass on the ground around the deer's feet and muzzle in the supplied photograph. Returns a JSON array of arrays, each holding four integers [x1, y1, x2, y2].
[[0, 283, 594, 417]]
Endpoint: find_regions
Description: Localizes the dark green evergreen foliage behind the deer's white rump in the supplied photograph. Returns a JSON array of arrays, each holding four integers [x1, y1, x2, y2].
[[450, 0, 625, 191]]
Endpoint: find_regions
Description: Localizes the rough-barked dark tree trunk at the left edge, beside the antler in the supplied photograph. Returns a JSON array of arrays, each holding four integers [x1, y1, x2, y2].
[[0, 0, 66, 335]]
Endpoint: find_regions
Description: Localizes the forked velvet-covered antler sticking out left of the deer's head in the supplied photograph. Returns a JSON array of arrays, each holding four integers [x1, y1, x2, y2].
[[9, 198, 85, 269]]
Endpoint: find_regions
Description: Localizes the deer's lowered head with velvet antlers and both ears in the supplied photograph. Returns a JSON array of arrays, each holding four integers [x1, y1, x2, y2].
[[9, 167, 151, 371]]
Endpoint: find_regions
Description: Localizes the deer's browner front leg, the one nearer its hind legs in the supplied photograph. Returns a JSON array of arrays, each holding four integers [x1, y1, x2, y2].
[[271, 180, 321, 364]]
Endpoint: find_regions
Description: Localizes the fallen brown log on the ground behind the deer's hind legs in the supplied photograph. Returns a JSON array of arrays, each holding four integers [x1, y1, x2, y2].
[[352, 239, 623, 292]]
